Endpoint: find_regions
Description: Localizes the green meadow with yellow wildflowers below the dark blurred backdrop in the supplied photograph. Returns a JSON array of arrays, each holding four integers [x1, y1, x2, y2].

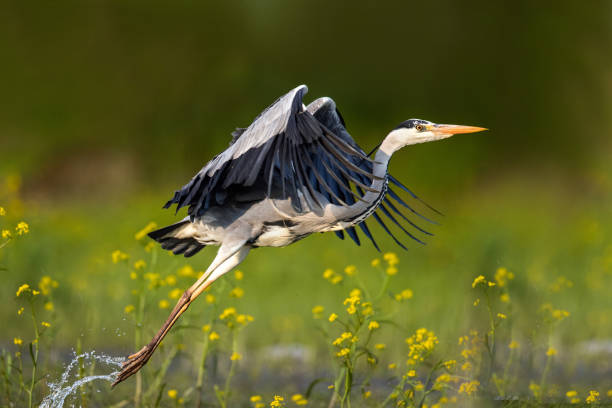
[[0, 158, 612, 407]]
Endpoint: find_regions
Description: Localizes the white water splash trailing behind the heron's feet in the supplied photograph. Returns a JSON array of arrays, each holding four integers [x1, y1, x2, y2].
[[40, 351, 124, 408]]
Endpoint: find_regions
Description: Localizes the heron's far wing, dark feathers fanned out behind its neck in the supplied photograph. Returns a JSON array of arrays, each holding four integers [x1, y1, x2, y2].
[[306, 98, 437, 251]]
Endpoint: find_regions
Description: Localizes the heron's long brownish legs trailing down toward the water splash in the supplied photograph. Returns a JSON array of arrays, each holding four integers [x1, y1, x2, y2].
[[113, 241, 251, 386]]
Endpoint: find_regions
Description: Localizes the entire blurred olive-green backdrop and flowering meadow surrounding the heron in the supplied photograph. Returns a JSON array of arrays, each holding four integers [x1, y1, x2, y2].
[[0, 0, 612, 408]]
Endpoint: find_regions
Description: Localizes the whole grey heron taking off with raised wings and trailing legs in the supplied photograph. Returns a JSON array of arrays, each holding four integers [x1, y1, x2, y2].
[[113, 85, 486, 385]]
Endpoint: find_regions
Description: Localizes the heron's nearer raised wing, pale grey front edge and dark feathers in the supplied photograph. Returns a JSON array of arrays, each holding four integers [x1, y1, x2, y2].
[[164, 85, 374, 218]]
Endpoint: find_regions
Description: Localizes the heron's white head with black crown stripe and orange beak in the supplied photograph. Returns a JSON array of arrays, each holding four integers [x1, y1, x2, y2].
[[388, 119, 487, 149]]
